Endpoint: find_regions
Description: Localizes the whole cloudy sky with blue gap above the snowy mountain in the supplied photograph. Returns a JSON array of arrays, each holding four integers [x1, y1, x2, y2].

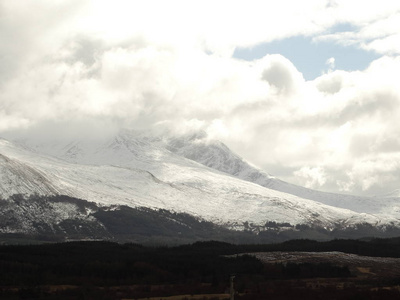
[[0, 0, 400, 195]]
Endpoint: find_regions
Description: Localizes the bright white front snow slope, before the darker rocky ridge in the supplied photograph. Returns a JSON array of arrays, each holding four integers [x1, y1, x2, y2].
[[0, 131, 390, 227]]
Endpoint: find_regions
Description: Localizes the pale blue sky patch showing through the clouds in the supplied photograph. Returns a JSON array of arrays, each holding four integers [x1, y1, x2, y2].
[[233, 34, 380, 80]]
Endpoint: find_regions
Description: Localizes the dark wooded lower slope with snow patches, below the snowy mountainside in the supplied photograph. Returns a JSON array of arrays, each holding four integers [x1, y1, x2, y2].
[[0, 195, 266, 244]]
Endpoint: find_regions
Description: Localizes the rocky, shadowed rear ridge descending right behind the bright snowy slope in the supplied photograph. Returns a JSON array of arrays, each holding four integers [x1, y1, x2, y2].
[[164, 133, 400, 218]]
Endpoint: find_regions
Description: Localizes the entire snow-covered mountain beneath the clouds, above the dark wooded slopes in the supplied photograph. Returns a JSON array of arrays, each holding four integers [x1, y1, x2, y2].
[[0, 130, 400, 241]]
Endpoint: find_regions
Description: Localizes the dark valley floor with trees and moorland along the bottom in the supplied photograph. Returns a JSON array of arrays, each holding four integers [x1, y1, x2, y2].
[[0, 238, 400, 300]]
